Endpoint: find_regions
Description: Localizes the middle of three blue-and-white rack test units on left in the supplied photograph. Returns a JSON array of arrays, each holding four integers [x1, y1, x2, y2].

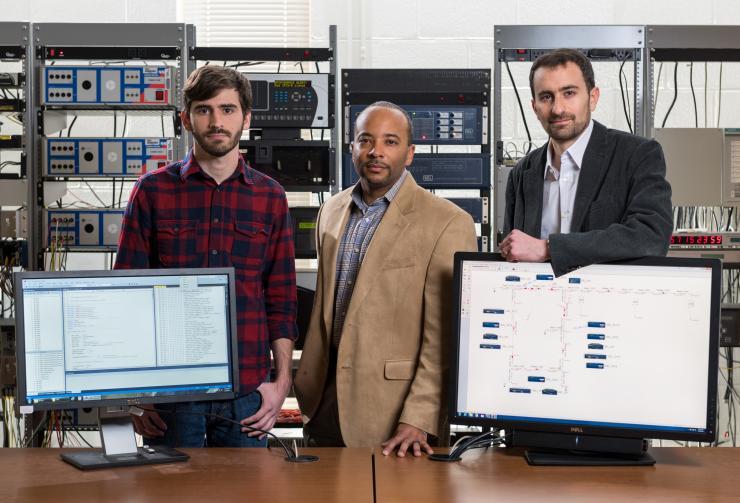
[[43, 138, 174, 177]]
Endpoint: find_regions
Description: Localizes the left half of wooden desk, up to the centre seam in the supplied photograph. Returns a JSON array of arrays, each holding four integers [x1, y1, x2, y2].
[[0, 448, 373, 503]]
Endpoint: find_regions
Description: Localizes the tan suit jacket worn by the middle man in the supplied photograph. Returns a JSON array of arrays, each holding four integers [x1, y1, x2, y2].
[[295, 173, 477, 447]]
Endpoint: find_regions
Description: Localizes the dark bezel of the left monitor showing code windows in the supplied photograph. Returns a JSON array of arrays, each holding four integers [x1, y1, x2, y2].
[[14, 267, 239, 411]]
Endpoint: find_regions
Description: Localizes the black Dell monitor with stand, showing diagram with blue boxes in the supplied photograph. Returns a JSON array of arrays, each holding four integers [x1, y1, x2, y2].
[[450, 253, 721, 464]]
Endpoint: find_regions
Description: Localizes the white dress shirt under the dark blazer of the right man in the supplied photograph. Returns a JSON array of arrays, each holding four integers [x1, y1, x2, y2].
[[540, 120, 594, 239]]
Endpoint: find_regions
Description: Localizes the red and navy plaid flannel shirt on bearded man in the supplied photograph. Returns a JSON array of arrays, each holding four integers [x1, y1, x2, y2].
[[115, 151, 298, 393]]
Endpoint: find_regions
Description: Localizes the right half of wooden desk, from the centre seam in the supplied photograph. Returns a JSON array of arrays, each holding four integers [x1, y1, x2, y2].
[[374, 447, 740, 503]]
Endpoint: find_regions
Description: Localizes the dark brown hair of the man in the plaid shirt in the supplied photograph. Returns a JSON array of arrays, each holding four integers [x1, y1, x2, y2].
[[182, 65, 252, 115]]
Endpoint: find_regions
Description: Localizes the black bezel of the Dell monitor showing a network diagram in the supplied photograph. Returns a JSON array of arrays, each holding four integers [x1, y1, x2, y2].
[[449, 252, 722, 442]]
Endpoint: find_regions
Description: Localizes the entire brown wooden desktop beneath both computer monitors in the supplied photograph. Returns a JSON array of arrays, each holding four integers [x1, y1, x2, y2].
[[5, 448, 740, 503]]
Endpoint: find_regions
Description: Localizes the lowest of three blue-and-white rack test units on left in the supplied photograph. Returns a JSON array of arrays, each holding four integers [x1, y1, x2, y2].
[[44, 209, 124, 249]]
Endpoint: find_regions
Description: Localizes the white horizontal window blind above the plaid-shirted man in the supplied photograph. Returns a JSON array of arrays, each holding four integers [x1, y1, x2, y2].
[[180, 0, 310, 47]]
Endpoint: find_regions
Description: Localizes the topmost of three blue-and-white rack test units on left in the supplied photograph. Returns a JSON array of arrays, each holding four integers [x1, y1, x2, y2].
[[41, 66, 177, 107]]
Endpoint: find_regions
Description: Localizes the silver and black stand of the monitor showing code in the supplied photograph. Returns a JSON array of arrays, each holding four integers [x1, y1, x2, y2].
[[61, 407, 190, 470]]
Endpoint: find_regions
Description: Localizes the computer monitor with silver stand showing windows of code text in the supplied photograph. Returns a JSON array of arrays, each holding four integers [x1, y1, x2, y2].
[[15, 268, 239, 469]]
